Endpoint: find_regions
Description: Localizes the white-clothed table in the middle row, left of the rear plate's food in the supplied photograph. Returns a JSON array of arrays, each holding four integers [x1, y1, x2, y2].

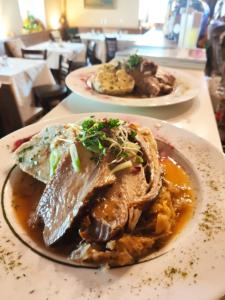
[[27, 41, 86, 69]]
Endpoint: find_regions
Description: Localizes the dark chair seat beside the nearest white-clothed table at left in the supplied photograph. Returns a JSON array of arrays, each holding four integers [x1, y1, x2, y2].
[[33, 84, 68, 99]]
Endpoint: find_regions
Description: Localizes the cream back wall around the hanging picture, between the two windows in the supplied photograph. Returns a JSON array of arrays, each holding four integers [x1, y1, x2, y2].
[[45, 0, 139, 28]]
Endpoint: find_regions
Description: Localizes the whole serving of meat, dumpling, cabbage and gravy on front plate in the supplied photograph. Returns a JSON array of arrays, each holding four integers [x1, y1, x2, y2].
[[13, 117, 194, 266]]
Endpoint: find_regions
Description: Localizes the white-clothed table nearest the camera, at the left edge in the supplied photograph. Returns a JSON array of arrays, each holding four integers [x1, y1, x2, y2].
[[0, 58, 55, 121]]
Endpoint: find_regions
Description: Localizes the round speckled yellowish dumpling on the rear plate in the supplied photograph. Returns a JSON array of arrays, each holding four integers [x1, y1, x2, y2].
[[92, 64, 135, 96]]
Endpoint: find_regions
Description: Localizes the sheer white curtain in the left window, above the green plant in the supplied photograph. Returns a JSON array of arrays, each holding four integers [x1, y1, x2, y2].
[[18, 0, 46, 26]]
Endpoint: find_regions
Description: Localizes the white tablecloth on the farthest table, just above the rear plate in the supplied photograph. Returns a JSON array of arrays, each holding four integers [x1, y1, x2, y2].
[[80, 32, 143, 62]]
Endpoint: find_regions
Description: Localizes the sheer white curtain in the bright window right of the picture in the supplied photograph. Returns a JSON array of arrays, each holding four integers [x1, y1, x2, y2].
[[139, 0, 168, 24]]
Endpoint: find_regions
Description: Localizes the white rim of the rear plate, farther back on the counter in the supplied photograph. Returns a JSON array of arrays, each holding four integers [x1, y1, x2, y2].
[[66, 65, 198, 107]]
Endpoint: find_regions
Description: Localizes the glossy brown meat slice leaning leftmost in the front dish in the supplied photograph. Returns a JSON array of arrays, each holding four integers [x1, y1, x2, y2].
[[36, 143, 115, 246]]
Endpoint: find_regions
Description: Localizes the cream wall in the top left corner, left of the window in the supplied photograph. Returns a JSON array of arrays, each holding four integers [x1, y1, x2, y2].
[[0, 0, 22, 39]]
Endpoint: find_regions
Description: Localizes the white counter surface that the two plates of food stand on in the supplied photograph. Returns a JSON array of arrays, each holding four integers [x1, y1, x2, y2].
[[44, 70, 222, 151]]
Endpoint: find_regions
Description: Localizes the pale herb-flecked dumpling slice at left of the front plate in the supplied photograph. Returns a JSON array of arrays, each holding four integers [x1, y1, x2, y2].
[[14, 125, 75, 183]]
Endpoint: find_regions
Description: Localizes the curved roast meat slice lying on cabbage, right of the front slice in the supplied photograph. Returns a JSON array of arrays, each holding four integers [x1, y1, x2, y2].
[[80, 125, 162, 242]]
